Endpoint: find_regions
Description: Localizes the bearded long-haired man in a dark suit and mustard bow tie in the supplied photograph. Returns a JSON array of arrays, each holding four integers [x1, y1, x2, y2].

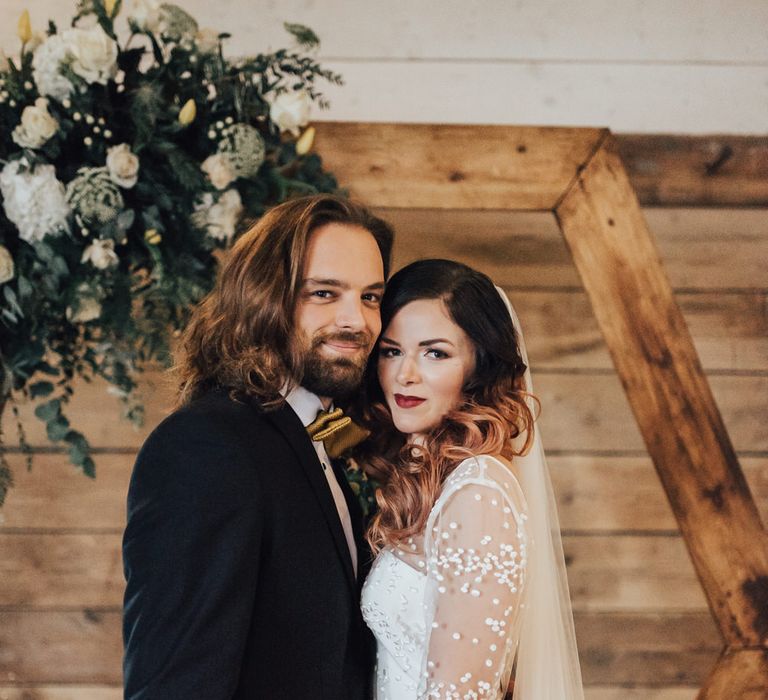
[[123, 195, 392, 700]]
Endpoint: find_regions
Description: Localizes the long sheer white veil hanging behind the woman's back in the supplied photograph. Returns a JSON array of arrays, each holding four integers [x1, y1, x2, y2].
[[497, 287, 584, 700]]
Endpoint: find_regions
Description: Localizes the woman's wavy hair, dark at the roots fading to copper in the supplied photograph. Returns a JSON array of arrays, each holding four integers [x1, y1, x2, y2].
[[357, 260, 534, 552]]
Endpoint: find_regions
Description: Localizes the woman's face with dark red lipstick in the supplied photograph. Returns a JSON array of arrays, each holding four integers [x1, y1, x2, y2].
[[378, 299, 475, 440]]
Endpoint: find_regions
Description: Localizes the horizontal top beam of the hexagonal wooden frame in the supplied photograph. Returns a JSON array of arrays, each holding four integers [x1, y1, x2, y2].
[[315, 122, 602, 210]]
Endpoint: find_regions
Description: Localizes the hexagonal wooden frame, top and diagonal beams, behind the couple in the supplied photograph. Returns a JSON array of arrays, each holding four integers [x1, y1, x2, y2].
[[317, 123, 768, 700]]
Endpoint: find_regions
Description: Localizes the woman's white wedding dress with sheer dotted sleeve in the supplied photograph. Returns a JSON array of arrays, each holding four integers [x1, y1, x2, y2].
[[362, 455, 529, 700]]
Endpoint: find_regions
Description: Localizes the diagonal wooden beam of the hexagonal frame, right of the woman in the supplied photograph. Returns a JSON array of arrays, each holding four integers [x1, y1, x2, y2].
[[555, 136, 768, 646]]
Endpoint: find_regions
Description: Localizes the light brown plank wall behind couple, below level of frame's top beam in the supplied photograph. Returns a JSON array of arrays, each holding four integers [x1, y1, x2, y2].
[[0, 209, 768, 700]]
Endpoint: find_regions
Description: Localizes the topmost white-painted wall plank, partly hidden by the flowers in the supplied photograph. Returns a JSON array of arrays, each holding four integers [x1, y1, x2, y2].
[[0, 0, 768, 64]]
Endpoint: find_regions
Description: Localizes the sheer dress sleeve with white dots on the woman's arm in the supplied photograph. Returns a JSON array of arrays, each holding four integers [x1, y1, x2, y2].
[[419, 457, 528, 700]]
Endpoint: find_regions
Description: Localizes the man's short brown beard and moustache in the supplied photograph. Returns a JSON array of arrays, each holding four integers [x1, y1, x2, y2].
[[301, 331, 373, 399]]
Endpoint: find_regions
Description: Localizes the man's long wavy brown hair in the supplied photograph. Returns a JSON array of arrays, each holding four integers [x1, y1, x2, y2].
[[174, 194, 393, 409]]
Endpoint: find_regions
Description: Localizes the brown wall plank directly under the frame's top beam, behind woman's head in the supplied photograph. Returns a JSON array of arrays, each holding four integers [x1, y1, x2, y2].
[[388, 202, 768, 290]]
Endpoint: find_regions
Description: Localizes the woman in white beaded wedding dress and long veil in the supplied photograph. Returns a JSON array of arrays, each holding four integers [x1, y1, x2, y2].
[[360, 260, 583, 700]]
